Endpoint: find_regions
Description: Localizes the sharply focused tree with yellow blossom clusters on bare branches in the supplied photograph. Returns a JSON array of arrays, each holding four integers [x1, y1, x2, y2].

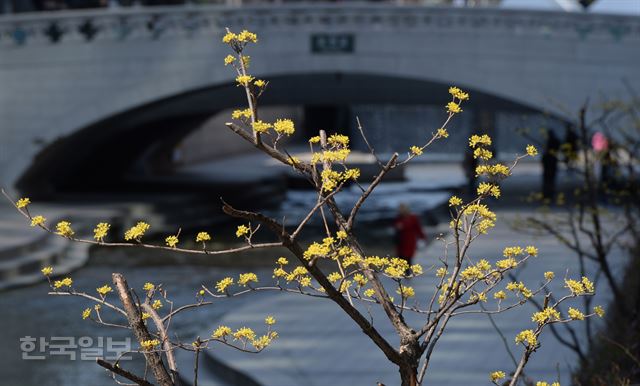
[[3, 30, 602, 386]]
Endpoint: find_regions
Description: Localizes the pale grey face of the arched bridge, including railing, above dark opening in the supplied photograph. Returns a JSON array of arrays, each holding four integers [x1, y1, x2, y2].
[[0, 4, 640, 190]]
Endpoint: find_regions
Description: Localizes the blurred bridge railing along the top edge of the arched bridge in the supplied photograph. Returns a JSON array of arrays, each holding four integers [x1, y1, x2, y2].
[[0, 3, 640, 49]]
